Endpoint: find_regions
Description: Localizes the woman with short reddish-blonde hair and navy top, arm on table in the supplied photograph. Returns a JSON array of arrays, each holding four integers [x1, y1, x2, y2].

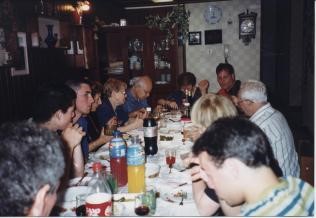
[[96, 78, 143, 132]]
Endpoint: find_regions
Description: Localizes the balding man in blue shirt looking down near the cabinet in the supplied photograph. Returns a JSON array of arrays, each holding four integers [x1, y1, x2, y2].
[[123, 76, 153, 114]]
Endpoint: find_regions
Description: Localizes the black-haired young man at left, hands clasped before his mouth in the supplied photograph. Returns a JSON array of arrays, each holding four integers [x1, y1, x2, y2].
[[32, 84, 85, 179]]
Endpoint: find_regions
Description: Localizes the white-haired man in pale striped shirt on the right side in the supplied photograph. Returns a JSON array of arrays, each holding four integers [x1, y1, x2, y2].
[[237, 80, 300, 177]]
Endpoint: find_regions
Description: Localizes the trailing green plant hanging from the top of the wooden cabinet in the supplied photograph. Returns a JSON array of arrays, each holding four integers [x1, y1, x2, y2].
[[145, 5, 190, 44]]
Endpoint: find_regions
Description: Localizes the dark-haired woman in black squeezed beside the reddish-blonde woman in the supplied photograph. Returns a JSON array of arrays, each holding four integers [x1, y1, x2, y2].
[[87, 81, 112, 151]]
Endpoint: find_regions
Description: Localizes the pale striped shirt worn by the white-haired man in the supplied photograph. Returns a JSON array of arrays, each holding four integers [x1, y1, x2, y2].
[[250, 103, 300, 177]]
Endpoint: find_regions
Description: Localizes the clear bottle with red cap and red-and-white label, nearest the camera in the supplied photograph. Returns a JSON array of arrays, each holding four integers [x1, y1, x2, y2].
[[85, 162, 112, 216]]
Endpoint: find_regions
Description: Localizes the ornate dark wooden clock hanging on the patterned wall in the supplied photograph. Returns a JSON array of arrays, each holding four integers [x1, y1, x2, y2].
[[238, 10, 257, 45]]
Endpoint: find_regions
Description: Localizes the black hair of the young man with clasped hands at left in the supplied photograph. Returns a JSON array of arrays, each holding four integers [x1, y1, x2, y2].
[[32, 84, 76, 123]]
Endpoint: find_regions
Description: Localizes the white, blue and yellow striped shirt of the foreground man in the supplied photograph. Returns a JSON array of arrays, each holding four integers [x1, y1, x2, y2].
[[240, 177, 314, 216]]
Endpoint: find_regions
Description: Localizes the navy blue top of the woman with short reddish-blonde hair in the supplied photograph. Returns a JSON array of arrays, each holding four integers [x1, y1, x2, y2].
[[96, 98, 128, 127]]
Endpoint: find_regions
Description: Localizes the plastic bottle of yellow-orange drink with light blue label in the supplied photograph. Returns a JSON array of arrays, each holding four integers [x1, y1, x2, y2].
[[127, 136, 145, 193]]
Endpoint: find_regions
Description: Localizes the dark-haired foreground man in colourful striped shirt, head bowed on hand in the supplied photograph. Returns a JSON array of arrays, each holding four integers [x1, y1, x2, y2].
[[192, 117, 314, 216]]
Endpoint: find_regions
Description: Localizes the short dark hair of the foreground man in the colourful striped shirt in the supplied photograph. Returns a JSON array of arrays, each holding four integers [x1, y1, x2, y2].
[[192, 117, 282, 176]]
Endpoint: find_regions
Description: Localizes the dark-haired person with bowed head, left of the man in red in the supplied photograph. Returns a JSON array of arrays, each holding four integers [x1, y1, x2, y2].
[[158, 72, 209, 109]]
